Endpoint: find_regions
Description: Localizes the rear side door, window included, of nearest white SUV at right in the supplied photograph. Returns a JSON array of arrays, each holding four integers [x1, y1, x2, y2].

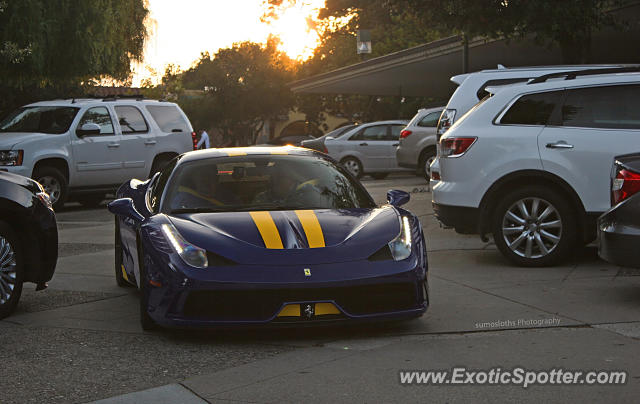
[[538, 85, 640, 212]]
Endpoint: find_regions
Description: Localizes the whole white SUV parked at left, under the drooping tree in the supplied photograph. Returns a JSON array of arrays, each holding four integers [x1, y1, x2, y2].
[[0, 98, 195, 208]]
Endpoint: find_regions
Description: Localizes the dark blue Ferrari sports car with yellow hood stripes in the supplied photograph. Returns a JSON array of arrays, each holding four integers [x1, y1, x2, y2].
[[109, 146, 429, 330]]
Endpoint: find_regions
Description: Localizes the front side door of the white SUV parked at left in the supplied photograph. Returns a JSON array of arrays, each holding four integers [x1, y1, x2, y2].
[[71, 106, 124, 186]]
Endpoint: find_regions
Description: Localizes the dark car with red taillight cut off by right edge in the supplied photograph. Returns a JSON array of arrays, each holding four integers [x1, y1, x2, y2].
[[598, 154, 640, 267]]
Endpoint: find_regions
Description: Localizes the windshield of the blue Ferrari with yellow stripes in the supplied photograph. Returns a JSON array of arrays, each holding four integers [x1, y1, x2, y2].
[[161, 155, 375, 213]]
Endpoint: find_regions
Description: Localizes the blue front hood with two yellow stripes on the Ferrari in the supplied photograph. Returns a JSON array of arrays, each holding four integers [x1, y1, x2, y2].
[[165, 205, 400, 265]]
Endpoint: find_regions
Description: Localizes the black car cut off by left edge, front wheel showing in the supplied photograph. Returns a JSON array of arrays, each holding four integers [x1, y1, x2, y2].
[[0, 171, 58, 319]]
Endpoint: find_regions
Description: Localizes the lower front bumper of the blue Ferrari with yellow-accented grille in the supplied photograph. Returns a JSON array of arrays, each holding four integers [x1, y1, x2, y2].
[[145, 254, 428, 327]]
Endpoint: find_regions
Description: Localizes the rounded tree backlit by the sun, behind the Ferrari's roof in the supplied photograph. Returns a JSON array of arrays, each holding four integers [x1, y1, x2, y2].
[[180, 38, 294, 145]]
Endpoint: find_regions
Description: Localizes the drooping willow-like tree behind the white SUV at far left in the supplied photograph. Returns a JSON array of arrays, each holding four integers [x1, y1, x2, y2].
[[0, 0, 148, 110]]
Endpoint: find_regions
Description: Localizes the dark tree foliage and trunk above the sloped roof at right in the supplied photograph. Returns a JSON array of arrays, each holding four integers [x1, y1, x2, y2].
[[400, 0, 625, 63]]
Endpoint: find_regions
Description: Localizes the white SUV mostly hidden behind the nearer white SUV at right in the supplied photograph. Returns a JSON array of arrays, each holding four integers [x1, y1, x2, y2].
[[430, 65, 624, 186]]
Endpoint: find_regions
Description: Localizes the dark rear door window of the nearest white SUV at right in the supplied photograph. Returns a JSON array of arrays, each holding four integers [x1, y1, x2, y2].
[[562, 85, 640, 129]]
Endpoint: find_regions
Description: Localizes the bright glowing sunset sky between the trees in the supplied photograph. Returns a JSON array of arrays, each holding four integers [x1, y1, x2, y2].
[[133, 0, 325, 86]]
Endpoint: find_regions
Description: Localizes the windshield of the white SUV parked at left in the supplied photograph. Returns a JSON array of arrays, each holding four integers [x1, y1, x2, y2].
[[0, 107, 79, 134]]
